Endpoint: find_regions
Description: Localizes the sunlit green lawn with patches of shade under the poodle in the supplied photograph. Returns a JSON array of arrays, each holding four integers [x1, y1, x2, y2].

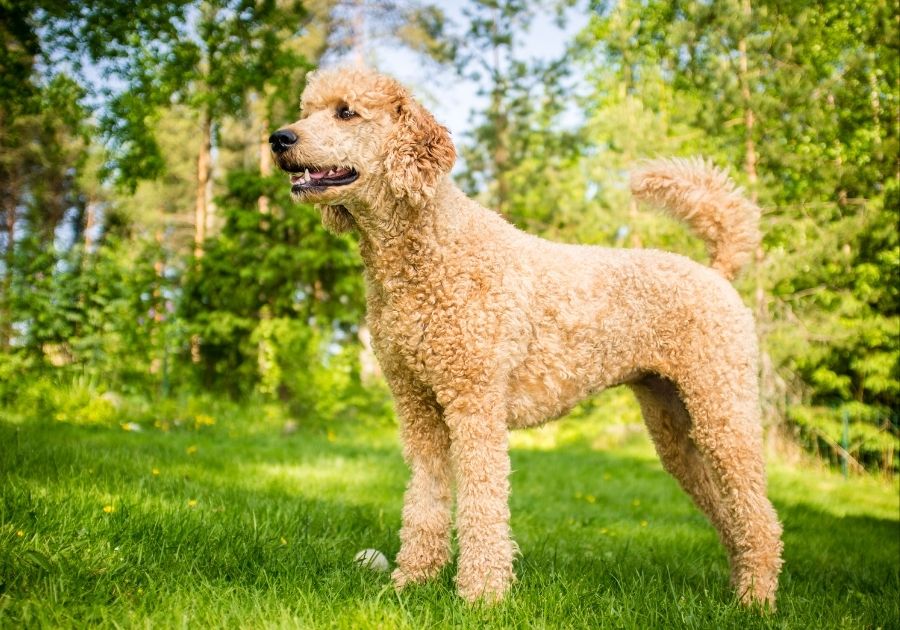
[[0, 402, 900, 629]]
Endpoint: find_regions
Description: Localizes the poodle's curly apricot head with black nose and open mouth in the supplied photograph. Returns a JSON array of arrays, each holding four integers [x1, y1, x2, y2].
[[269, 69, 456, 232]]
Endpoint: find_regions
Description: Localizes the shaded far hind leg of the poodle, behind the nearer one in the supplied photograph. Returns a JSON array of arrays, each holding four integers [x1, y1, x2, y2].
[[631, 376, 734, 557]]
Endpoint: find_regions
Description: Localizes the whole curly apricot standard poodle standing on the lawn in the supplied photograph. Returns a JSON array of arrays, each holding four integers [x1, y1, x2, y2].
[[270, 69, 782, 606]]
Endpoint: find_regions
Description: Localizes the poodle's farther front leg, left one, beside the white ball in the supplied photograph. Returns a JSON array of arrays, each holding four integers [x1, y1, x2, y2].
[[392, 382, 452, 588]]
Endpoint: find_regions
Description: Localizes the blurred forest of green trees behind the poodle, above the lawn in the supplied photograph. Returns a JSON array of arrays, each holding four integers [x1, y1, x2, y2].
[[0, 0, 900, 476]]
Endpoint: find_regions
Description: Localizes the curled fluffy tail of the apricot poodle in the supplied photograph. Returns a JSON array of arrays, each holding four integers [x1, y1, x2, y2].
[[631, 157, 761, 280]]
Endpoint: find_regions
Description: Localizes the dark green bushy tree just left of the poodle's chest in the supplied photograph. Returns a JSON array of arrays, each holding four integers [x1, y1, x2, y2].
[[181, 172, 362, 399]]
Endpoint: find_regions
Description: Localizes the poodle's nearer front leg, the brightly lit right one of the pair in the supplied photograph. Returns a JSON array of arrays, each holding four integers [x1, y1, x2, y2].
[[445, 394, 516, 602]]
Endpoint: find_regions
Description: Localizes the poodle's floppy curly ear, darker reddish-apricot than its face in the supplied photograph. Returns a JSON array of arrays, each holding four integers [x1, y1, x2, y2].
[[384, 95, 456, 206]]
